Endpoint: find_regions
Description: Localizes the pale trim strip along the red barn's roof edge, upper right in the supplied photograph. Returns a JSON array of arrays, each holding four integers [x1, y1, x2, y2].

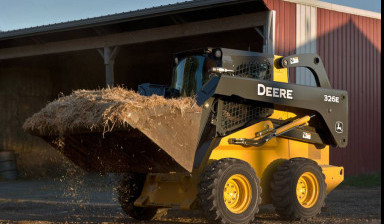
[[283, 0, 381, 20]]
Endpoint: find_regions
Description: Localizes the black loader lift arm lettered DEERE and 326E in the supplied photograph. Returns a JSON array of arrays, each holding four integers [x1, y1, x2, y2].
[[197, 54, 348, 147]]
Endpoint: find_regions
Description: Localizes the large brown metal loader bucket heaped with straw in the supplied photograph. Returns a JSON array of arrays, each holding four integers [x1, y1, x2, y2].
[[24, 87, 201, 173]]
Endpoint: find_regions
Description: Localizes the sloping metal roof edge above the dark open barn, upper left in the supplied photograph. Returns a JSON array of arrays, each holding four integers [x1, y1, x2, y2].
[[0, 0, 262, 40]]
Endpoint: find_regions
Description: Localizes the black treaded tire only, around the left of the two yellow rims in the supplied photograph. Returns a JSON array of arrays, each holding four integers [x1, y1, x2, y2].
[[198, 159, 261, 224]]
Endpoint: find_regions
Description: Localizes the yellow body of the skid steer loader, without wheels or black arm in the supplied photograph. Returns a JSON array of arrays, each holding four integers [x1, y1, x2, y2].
[[135, 56, 344, 209]]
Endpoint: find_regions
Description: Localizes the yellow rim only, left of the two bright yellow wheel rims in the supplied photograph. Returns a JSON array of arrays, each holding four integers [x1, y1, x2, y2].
[[224, 174, 252, 214]]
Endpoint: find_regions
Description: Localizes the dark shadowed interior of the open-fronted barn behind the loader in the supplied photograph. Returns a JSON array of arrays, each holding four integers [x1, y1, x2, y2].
[[0, 1, 269, 176]]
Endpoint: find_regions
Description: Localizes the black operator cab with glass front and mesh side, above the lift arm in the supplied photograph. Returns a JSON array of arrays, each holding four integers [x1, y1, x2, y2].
[[139, 48, 274, 97]]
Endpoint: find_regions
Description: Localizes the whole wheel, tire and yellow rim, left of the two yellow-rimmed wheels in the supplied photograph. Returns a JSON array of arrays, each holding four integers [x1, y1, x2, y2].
[[199, 159, 261, 224]]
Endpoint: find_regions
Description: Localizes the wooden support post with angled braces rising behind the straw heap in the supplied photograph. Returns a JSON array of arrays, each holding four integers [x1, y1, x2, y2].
[[97, 46, 120, 88]]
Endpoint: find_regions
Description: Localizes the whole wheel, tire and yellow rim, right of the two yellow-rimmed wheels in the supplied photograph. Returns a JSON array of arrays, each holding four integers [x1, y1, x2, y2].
[[271, 158, 326, 220]]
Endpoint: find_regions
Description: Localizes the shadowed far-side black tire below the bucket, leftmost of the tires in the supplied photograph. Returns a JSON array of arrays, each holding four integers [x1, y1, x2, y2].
[[117, 174, 158, 220]]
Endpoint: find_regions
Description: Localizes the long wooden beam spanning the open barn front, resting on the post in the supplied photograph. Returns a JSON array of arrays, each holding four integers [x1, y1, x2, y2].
[[0, 12, 268, 60]]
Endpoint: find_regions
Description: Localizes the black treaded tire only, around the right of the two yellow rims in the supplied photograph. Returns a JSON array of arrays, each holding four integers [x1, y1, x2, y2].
[[271, 158, 327, 220]]
